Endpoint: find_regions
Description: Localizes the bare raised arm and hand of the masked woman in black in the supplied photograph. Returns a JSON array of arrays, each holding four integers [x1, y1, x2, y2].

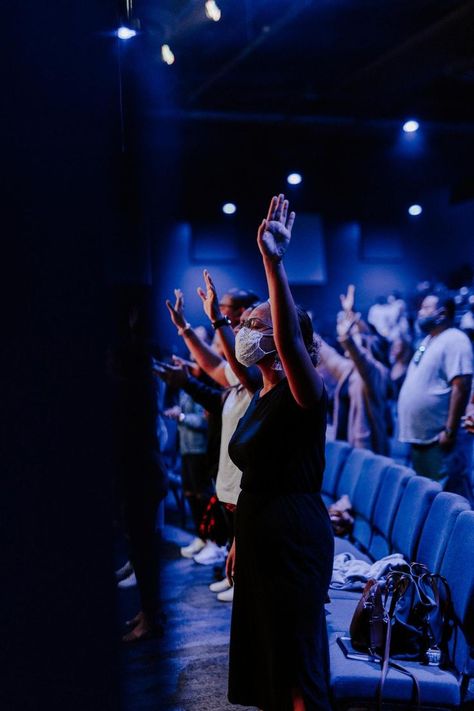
[[257, 194, 324, 408]]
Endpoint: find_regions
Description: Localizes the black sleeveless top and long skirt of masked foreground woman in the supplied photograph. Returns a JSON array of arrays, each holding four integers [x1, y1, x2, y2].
[[229, 378, 334, 711]]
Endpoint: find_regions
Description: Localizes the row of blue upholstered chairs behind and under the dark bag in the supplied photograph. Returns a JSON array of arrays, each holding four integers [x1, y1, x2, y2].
[[323, 441, 474, 709]]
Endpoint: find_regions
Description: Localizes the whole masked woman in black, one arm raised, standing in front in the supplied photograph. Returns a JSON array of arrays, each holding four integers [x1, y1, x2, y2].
[[227, 195, 334, 711]]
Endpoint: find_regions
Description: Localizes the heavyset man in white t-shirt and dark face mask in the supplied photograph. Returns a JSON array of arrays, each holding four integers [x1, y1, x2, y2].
[[398, 294, 473, 503]]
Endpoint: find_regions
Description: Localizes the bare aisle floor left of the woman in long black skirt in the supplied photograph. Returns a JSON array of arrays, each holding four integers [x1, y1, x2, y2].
[[119, 515, 258, 711]]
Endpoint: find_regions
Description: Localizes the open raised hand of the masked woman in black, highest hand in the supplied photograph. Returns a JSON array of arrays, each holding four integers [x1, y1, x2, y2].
[[257, 194, 295, 262]]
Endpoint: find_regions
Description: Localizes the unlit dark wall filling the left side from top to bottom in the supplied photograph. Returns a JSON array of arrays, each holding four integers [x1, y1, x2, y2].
[[0, 0, 120, 711]]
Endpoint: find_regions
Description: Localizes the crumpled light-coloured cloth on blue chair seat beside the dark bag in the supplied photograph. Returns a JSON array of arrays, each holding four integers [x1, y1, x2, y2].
[[329, 553, 407, 592]]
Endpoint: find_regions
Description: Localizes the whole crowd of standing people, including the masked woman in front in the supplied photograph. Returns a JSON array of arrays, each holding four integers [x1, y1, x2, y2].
[[115, 195, 474, 711]]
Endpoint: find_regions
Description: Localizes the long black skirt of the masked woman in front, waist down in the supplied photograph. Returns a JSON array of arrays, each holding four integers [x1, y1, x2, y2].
[[229, 491, 334, 711]]
